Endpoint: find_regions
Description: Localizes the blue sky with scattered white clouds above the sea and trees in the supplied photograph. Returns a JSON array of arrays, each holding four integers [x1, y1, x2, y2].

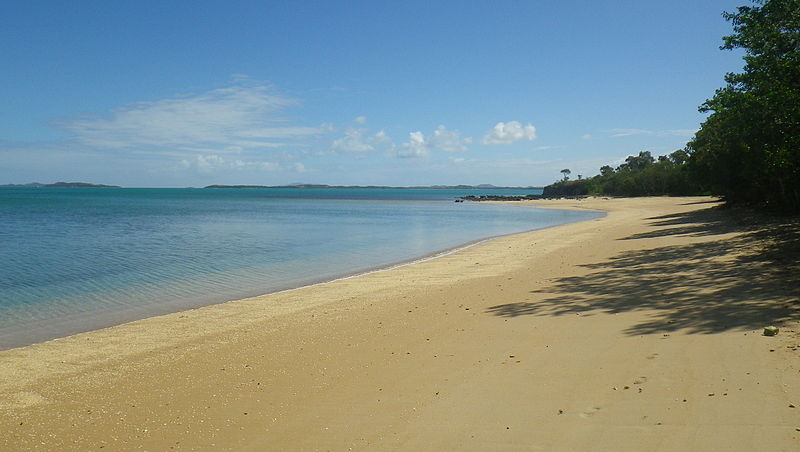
[[0, 0, 750, 187]]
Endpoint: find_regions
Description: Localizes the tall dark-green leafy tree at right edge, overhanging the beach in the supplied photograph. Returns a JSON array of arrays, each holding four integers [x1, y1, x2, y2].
[[688, 0, 800, 212]]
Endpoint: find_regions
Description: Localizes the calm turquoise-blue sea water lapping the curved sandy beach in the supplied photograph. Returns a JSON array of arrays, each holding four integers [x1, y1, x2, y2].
[[0, 188, 598, 348]]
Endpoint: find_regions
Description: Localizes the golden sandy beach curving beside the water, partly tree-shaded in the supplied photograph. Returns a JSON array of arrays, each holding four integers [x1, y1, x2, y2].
[[0, 198, 800, 451]]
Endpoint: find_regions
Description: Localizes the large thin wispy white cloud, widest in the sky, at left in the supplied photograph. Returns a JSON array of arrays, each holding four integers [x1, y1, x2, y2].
[[58, 84, 325, 155]]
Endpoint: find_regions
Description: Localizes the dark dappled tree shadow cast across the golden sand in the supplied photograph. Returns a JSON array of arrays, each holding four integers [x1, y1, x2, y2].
[[488, 207, 800, 335]]
